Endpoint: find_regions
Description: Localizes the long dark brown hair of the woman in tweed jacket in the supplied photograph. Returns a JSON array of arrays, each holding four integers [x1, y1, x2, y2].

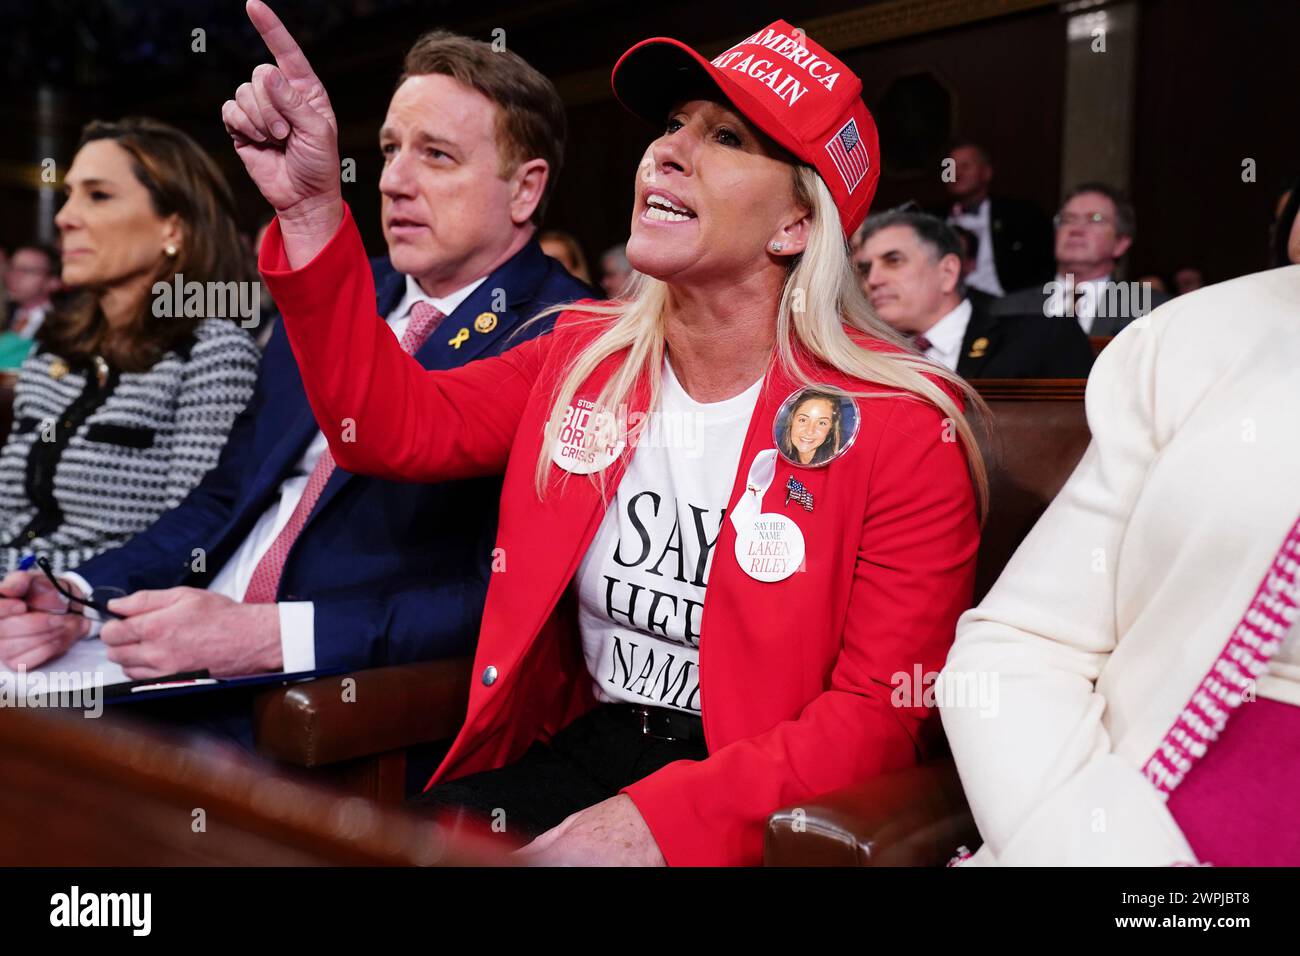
[[44, 117, 255, 372]]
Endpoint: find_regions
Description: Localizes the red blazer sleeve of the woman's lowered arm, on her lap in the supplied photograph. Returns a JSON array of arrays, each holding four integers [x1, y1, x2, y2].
[[624, 399, 979, 865]]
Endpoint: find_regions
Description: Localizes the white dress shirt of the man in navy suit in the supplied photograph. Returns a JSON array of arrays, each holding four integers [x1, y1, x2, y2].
[[65, 269, 486, 674]]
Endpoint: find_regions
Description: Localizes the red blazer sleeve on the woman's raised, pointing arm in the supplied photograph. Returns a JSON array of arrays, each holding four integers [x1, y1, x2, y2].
[[257, 209, 550, 481]]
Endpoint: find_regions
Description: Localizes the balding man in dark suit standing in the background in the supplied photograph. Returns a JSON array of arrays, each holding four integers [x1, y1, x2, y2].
[[936, 142, 1052, 297]]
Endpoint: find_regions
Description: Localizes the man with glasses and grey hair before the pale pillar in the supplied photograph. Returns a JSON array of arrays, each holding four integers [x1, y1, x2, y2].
[[991, 182, 1170, 336]]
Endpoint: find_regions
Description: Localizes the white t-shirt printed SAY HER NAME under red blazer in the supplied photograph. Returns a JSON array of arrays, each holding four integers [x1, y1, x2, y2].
[[577, 359, 763, 714]]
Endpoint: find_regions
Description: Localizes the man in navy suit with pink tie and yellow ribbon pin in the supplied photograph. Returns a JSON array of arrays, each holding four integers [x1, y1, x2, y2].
[[0, 33, 592, 678]]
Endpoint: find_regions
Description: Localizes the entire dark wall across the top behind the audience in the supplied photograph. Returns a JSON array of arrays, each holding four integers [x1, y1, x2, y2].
[[0, 0, 1300, 280]]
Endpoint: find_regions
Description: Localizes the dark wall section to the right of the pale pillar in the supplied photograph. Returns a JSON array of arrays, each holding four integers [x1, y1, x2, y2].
[[1132, 0, 1300, 281]]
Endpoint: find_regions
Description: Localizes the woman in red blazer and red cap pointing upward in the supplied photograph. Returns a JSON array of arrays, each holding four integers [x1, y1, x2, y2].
[[224, 3, 983, 865]]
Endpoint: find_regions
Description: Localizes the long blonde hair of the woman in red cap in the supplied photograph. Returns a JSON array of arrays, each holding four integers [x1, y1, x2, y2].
[[534, 165, 988, 522]]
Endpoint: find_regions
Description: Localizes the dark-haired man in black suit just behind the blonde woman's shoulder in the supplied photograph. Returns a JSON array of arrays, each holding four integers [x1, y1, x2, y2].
[[854, 212, 1092, 378]]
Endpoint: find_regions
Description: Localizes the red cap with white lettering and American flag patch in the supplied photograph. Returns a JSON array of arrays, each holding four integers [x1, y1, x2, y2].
[[611, 20, 880, 235]]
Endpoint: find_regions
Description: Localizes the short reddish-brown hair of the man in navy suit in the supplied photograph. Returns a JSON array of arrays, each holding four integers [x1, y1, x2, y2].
[[398, 30, 567, 225]]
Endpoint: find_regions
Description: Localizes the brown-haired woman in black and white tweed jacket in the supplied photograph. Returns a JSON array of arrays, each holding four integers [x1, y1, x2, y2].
[[0, 120, 259, 572]]
